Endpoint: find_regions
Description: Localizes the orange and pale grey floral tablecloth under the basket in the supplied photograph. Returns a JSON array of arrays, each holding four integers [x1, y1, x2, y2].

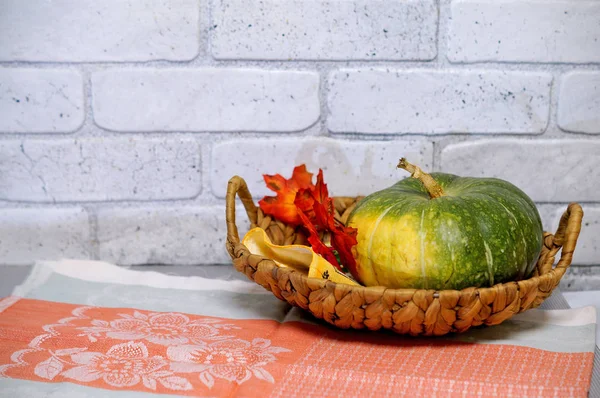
[[0, 262, 595, 397]]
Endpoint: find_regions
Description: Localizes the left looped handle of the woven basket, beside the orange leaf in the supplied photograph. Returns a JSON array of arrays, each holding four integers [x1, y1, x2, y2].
[[225, 176, 258, 247]]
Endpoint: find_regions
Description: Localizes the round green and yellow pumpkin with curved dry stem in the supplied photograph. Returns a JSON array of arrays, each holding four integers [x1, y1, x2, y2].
[[347, 159, 543, 290]]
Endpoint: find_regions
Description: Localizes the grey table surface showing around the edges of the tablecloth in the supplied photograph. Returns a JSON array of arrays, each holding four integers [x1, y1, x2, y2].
[[0, 265, 600, 398]]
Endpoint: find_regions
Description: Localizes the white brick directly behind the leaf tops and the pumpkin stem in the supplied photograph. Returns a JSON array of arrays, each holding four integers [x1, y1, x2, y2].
[[211, 138, 433, 197]]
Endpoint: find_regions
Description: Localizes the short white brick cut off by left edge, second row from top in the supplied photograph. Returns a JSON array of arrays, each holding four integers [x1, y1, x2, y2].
[[0, 67, 85, 133]]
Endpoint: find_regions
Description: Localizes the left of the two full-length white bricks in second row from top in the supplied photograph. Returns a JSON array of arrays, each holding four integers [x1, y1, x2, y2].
[[92, 68, 320, 132]]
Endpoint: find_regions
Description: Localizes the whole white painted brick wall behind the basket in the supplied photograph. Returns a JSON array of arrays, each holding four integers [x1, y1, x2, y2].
[[0, 0, 600, 288]]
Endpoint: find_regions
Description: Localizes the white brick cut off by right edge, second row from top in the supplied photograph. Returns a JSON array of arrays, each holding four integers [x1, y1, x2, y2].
[[558, 71, 600, 134]]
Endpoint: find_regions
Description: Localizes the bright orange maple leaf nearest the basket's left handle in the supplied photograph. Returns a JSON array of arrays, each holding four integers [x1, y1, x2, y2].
[[258, 165, 314, 226]]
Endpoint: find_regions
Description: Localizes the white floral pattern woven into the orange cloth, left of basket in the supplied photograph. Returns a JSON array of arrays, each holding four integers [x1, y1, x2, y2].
[[0, 300, 290, 391]]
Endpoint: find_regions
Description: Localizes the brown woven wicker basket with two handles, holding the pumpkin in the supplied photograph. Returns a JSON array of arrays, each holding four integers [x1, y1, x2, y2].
[[226, 176, 583, 336]]
